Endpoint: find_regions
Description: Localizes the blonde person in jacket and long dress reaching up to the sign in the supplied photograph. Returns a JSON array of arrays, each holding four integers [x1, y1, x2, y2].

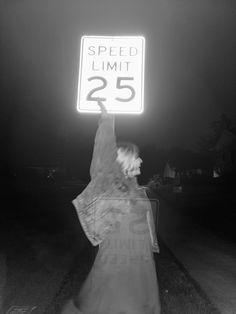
[[62, 102, 161, 314]]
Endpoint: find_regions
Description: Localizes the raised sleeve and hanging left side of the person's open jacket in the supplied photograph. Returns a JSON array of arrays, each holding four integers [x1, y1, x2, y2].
[[72, 113, 117, 246]]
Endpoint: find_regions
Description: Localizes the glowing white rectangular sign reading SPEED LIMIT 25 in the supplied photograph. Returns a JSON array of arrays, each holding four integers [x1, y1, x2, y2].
[[77, 36, 145, 114]]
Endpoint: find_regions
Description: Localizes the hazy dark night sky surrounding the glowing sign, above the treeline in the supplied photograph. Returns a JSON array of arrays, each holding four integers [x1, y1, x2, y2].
[[0, 0, 236, 168]]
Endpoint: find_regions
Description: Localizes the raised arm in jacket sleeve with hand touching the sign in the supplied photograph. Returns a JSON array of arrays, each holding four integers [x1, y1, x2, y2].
[[90, 102, 117, 180]]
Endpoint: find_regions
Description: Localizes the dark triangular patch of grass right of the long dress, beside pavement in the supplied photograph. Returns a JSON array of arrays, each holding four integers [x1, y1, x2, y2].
[[155, 241, 220, 314]]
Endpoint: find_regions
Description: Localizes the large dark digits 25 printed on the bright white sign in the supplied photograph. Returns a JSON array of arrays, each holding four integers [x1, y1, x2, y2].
[[87, 76, 135, 102]]
